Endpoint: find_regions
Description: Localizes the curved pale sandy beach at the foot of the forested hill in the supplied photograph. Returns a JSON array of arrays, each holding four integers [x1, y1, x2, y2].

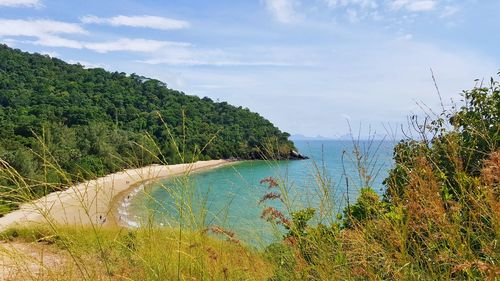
[[0, 160, 232, 231]]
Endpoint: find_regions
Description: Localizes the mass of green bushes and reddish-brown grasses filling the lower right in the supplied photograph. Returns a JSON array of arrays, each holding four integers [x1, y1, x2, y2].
[[263, 74, 500, 280]]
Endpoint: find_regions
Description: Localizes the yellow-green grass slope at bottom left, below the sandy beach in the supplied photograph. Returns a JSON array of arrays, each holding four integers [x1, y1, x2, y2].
[[2, 226, 271, 280]]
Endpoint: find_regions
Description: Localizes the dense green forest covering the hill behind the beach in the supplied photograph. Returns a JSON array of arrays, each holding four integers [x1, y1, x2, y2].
[[0, 45, 294, 212]]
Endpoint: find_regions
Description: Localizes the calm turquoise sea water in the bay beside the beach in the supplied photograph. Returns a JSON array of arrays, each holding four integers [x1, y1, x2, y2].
[[128, 141, 394, 245]]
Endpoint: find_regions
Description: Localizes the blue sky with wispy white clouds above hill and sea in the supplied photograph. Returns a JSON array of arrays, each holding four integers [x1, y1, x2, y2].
[[0, 0, 500, 137]]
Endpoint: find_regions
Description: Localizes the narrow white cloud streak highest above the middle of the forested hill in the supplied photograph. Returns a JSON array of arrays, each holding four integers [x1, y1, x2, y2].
[[80, 15, 189, 30]]
